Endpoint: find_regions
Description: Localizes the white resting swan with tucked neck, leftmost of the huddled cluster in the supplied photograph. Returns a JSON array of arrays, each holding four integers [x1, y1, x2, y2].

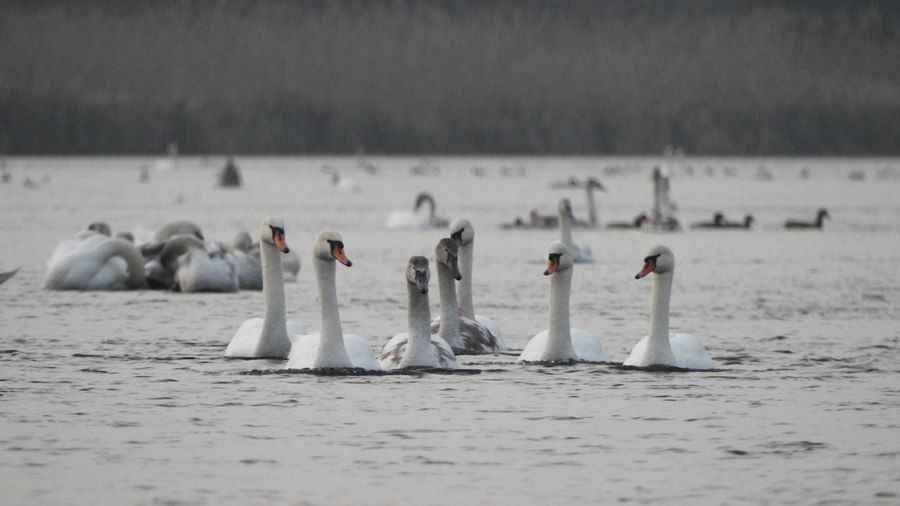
[[44, 234, 144, 290]]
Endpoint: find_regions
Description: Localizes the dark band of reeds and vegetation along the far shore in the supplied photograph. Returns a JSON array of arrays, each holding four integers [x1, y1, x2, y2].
[[0, 0, 900, 154]]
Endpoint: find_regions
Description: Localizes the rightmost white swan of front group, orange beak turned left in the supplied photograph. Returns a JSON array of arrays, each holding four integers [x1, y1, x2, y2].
[[624, 246, 715, 370]]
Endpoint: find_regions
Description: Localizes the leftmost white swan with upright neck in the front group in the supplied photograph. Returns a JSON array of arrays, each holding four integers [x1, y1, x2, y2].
[[225, 216, 305, 358]]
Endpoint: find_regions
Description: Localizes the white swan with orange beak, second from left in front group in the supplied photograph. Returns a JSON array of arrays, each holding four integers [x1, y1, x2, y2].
[[287, 232, 381, 370]]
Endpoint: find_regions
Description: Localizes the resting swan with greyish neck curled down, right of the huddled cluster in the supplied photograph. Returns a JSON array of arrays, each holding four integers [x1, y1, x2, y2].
[[159, 235, 240, 293]]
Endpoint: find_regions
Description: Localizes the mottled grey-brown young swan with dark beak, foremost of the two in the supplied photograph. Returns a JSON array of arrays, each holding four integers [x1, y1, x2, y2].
[[379, 256, 459, 370]]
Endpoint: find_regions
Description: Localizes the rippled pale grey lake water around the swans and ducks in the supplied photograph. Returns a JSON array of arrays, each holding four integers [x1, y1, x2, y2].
[[0, 158, 900, 504]]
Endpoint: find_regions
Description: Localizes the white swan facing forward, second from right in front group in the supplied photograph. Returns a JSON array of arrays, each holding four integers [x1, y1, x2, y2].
[[519, 242, 609, 362]]
